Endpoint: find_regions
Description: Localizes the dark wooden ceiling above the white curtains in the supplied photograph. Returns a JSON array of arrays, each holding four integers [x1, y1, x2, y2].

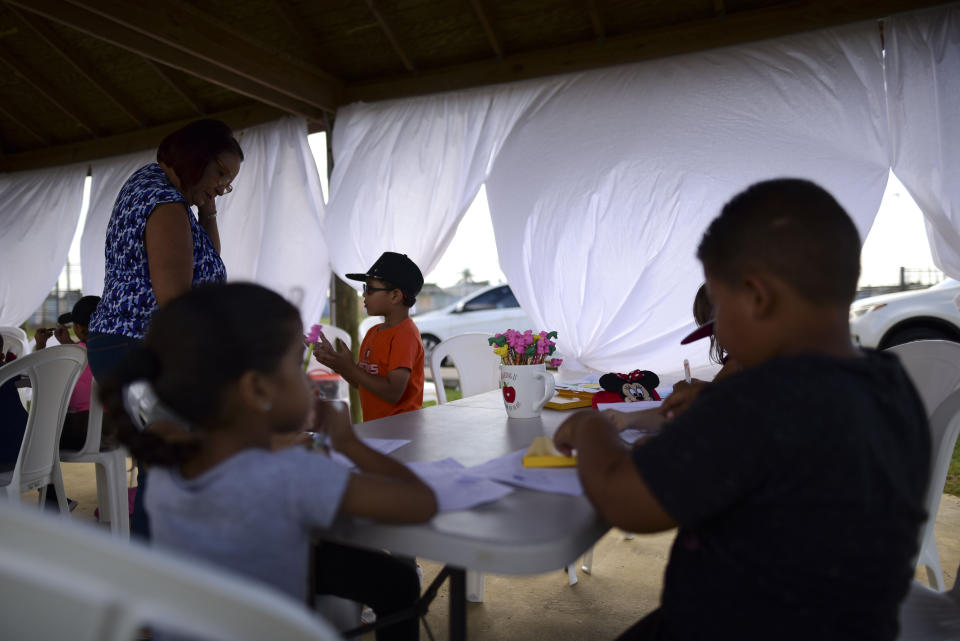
[[0, 0, 942, 171]]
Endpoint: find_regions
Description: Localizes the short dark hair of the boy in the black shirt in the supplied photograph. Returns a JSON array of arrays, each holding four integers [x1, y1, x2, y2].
[[697, 178, 860, 306]]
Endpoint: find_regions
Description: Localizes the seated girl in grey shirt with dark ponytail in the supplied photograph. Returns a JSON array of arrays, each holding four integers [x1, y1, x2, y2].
[[102, 283, 437, 641]]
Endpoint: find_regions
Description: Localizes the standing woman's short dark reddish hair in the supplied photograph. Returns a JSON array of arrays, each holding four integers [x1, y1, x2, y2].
[[157, 118, 243, 192]]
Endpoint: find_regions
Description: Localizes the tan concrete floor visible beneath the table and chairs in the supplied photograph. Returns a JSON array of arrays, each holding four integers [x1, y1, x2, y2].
[[35, 463, 960, 641]]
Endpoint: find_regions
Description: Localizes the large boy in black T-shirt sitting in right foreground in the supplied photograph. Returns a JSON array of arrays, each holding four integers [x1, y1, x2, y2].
[[555, 179, 930, 641]]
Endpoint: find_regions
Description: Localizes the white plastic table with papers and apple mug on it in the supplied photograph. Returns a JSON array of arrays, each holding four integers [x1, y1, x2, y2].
[[321, 390, 610, 640]]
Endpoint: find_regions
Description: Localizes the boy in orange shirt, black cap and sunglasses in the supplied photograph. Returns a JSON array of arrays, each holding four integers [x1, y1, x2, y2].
[[313, 252, 424, 421]]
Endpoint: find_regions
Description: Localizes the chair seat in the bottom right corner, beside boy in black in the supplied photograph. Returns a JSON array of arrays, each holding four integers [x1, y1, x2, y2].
[[897, 569, 960, 641]]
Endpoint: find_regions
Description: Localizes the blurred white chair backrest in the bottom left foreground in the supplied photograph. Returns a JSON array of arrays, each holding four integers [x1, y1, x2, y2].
[[0, 504, 340, 641]]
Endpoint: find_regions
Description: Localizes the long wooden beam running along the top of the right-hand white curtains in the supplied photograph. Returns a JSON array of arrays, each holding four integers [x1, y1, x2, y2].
[[343, 0, 945, 104]]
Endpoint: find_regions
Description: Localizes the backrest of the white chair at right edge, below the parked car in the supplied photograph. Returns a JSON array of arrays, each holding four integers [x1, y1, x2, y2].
[[887, 341, 960, 416]]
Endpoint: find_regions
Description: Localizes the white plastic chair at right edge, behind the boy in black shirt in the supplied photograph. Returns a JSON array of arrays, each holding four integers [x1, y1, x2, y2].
[[888, 341, 960, 590]]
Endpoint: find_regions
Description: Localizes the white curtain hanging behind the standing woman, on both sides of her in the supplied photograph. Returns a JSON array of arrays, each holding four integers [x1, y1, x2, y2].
[[79, 118, 330, 324]]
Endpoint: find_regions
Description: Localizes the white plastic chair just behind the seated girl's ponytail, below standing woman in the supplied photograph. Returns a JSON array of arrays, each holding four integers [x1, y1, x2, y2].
[[60, 381, 130, 538]]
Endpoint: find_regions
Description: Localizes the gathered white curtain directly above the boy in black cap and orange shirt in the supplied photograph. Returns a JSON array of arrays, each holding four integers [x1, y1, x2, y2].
[[327, 80, 564, 287]]
